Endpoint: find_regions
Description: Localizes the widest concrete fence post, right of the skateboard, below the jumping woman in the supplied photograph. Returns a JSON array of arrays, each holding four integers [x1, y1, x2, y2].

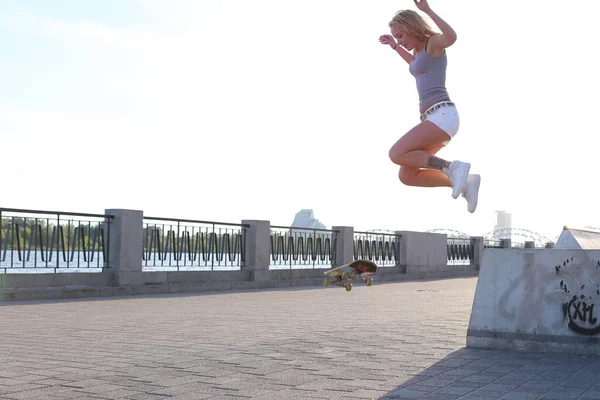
[[396, 231, 448, 273]]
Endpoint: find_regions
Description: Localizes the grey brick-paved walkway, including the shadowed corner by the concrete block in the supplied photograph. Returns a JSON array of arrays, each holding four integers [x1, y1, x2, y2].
[[0, 278, 600, 400]]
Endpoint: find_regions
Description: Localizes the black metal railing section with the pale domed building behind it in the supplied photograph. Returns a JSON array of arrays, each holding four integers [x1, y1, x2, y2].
[[269, 226, 339, 269]]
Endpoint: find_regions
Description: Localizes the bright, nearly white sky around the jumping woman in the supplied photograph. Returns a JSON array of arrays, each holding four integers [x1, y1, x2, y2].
[[0, 0, 600, 238]]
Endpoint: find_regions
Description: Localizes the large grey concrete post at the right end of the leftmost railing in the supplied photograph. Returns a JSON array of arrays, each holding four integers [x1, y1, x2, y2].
[[104, 209, 144, 286]]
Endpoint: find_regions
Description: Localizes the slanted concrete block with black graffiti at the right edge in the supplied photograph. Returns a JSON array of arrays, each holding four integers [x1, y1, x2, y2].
[[467, 249, 600, 354]]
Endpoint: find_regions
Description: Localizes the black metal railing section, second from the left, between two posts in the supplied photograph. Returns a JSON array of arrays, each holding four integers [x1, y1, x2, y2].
[[142, 217, 249, 271]]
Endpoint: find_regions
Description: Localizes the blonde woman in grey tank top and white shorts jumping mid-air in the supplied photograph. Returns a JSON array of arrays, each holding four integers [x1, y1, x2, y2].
[[379, 0, 481, 213]]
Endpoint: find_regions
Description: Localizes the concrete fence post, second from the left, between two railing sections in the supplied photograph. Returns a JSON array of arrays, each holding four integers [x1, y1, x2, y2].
[[242, 220, 271, 281]]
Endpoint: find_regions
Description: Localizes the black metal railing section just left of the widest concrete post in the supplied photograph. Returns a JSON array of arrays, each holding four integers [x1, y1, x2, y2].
[[354, 231, 401, 267]]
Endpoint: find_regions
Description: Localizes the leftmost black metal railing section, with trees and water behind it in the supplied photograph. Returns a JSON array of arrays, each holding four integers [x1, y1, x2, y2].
[[0, 208, 114, 273]]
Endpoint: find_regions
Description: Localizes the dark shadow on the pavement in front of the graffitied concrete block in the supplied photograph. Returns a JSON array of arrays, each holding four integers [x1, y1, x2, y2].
[[382, 347, 600, 400]]
